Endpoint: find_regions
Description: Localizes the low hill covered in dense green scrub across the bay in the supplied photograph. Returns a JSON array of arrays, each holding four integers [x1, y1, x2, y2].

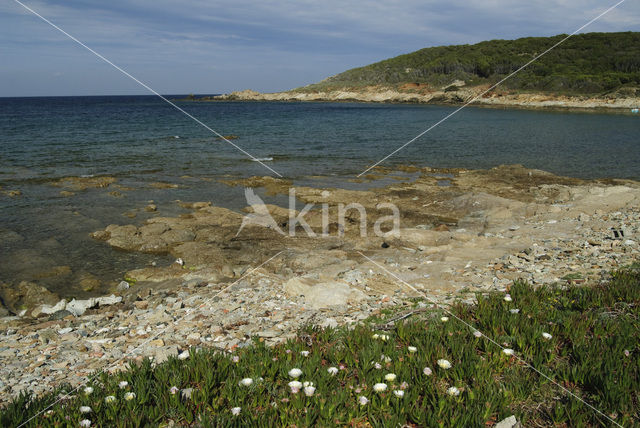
[[299, 32, 640, 95]]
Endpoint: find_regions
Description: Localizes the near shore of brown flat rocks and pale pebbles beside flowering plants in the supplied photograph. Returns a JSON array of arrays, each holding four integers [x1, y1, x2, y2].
[[0, 166, 640, 404]]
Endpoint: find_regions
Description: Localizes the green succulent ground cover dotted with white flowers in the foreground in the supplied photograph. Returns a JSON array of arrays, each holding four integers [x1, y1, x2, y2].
[[0, 268, 640, 427]]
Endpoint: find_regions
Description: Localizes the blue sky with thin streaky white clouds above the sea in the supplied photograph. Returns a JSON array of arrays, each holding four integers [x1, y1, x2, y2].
[[0, 0, 640, 97]]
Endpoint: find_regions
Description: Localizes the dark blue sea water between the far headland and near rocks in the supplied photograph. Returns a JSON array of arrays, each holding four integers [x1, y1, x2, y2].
[[0, 95, 640, 296]]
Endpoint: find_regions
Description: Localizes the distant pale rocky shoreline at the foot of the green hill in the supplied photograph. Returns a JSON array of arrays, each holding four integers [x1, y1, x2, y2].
[[206, 84, 640, 112]]
